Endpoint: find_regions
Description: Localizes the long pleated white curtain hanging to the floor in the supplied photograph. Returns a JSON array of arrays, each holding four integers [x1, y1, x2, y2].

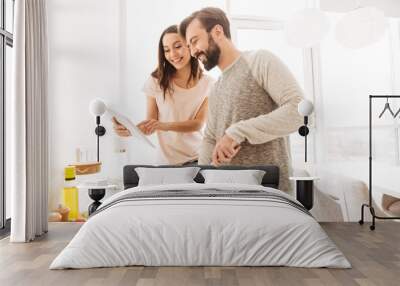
[[10, 0, 48, 242]]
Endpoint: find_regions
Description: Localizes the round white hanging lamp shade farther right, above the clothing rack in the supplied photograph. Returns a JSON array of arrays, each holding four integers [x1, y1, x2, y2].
[[335, 7, 387, 49]]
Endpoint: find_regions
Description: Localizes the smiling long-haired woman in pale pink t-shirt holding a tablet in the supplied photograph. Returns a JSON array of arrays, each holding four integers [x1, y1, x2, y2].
[[114, 25, 213, 164]]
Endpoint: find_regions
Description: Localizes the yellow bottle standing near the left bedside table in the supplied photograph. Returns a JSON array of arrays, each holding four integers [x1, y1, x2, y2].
[[63, 167, 79, 221]]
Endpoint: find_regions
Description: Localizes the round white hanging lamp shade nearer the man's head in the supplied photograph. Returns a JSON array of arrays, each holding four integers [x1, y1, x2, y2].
[[285, 8, 330, 48]]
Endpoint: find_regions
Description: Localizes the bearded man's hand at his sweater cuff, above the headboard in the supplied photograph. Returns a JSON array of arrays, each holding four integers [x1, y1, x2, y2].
[[212, 135, 240, 166]]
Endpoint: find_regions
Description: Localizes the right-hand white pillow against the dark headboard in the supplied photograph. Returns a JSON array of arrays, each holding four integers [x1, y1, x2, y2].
[[200, 169, 265, 185]]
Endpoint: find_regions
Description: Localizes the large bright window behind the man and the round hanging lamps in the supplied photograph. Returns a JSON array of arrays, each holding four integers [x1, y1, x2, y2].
[[228, 0, 400, 170]]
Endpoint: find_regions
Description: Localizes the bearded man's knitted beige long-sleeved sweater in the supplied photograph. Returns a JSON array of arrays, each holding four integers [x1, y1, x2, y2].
[[199, 50, 303, 192]]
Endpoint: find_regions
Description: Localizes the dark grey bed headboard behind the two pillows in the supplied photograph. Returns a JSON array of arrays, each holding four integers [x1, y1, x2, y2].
[[124, 165, 279, 189]]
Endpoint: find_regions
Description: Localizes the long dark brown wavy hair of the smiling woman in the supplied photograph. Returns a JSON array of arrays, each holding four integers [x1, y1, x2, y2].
[[151, 25, 203, 99]]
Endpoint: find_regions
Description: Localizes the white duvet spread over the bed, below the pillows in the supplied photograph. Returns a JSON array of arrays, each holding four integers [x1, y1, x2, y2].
[[50, 184, 351, 269]]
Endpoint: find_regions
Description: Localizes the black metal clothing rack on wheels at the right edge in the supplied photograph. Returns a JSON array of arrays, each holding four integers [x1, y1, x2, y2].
[[358, 95, 400, 230]]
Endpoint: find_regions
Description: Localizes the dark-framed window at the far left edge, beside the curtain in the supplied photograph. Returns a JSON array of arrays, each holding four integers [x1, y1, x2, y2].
[[0, 0, 14, 236]]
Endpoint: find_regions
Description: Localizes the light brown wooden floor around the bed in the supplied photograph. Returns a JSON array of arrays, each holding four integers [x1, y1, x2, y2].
[[0, 221, 400, 286]]
